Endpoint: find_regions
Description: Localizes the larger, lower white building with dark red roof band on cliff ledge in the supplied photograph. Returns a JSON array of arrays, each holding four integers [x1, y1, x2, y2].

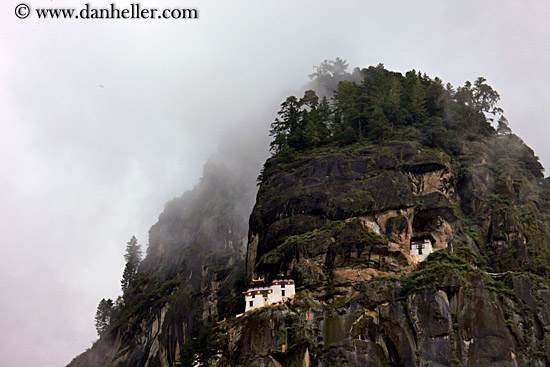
[[243, 277, 296, 312]]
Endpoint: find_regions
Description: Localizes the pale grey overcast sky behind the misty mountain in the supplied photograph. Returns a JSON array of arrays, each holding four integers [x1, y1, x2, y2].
[[0, 0, 550, 367]]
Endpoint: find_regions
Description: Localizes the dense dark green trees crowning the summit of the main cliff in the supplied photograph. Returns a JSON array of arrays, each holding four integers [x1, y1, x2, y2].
[[270, 59, 510, 158]]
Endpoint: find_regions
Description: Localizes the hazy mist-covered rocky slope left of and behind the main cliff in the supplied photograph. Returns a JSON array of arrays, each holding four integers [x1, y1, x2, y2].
[[69, 157, 257, 367]]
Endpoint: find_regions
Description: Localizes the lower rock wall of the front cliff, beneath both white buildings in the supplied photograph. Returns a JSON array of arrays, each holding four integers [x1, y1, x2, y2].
[[222, 255, 550, 367]]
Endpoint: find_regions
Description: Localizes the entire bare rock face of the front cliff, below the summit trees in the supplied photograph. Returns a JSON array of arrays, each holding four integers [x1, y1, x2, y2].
[[224, 136, 550, 367]]
